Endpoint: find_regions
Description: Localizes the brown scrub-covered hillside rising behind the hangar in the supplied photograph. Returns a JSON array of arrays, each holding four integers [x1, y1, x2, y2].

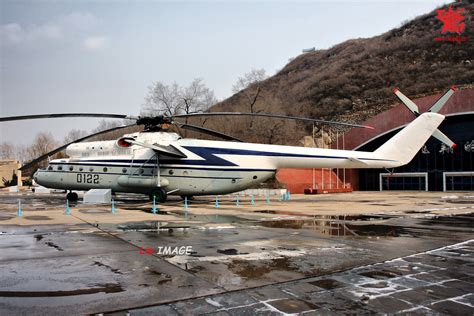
[[196, 3, 474, 144]]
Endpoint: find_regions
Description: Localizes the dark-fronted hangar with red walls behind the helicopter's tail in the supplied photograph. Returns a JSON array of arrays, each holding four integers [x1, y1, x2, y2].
[[277, 87, 474, 193]]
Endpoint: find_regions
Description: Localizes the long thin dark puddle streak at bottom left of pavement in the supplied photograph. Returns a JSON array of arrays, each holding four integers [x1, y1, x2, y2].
[[0, 283, 123, 297]]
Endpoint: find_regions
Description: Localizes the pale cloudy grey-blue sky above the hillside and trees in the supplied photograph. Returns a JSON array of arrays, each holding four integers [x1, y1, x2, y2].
[[0, 0, 447, 145]]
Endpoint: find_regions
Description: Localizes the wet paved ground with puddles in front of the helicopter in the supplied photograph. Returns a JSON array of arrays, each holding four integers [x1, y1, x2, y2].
[[0, 193, 474, 315]]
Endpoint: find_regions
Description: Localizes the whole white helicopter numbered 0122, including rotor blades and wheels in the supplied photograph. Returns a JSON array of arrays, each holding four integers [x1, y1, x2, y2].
[[0, 90, 454, 203]]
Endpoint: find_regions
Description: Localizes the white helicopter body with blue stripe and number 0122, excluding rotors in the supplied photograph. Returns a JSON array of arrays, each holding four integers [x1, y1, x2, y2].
[[34, 113, 444, 196]]
